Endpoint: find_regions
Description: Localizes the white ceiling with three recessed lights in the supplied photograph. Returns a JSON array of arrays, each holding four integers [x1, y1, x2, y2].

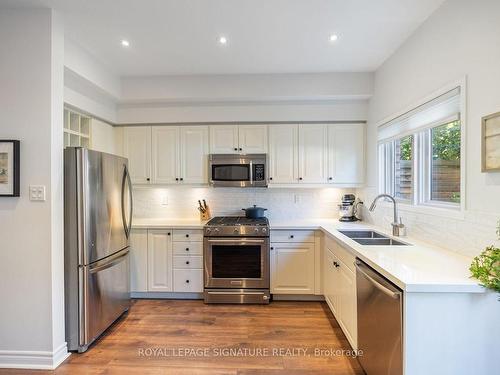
[[0, 0, 444, 76]]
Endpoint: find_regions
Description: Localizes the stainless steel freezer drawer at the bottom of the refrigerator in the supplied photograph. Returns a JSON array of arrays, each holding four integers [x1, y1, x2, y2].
[[79, 248, 130, 351]]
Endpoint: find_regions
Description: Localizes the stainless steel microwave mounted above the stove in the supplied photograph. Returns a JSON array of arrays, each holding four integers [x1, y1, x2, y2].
[[209, 154, 267, 187]]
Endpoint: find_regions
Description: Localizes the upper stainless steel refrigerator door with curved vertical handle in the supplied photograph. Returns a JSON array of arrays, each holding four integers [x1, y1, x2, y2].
[[81, 149, 132, 265]]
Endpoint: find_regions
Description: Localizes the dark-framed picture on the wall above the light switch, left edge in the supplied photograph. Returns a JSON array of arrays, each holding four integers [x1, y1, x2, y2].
[[0, 139, 20, 197]]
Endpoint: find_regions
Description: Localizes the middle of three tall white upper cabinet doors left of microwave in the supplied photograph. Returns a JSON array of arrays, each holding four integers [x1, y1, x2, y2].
[[152, 126, 179, 184]]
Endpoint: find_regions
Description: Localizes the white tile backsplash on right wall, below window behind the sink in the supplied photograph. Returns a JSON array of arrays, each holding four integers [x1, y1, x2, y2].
[[357, 189, 500, 256]]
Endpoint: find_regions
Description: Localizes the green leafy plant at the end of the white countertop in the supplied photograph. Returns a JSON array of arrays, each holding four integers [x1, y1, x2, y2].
[[469, 246, 500, 293]]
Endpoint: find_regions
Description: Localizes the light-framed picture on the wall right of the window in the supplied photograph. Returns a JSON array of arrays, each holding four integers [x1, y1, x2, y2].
[[481, 112, 500, 172]]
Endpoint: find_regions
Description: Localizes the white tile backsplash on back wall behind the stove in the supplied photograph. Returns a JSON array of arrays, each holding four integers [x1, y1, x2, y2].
[[133, 186, 353, 219]]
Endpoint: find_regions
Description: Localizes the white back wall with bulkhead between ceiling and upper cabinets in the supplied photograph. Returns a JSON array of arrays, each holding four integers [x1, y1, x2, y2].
[[117, 73, 373, 124]]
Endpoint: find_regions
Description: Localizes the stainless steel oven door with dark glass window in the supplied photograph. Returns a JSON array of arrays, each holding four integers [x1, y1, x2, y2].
[[203, 237, 269, 289]]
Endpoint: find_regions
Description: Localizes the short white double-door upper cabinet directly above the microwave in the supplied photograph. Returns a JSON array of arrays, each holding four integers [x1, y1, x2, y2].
[[210, 125, 267, 154]]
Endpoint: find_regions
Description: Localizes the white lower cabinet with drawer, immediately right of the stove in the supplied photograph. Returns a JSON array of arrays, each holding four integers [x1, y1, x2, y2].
[[271, 230, 315, 294]]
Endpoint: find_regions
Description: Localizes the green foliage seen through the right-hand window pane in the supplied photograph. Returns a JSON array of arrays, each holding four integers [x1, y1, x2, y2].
[[432, 121, 460, 160]]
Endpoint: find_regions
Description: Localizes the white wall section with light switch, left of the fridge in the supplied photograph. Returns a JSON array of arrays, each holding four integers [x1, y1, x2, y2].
[[0, 9, 66, 368]]
